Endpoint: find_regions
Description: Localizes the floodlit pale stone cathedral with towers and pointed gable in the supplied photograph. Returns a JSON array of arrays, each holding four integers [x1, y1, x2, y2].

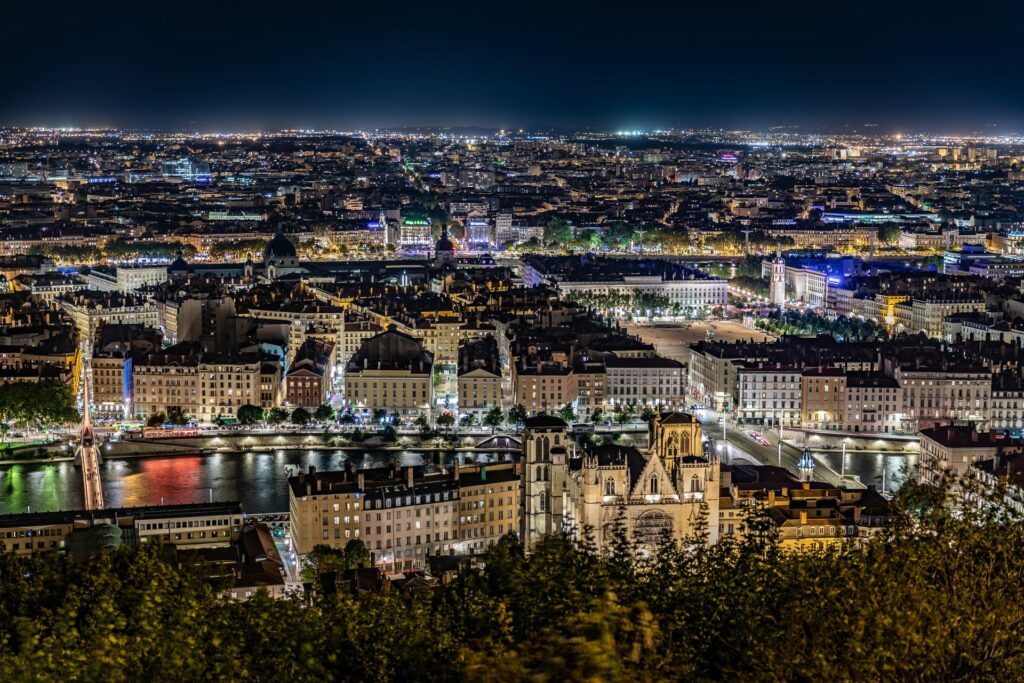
[[522, 413, 721, 554]]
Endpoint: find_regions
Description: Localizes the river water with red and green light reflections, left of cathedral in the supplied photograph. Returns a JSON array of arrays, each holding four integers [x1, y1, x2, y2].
[[0, 449, 509, 514]]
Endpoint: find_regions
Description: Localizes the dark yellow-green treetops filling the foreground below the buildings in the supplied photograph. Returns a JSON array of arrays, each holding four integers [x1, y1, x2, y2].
[[0, 487, 1024, 683]]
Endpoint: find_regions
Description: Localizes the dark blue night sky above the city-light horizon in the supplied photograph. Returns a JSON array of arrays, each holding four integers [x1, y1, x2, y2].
[[0, 0, 1024, 132]]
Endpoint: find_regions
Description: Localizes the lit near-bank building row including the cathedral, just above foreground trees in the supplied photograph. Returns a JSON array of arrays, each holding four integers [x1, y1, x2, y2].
[[289, 413, 889, 571]]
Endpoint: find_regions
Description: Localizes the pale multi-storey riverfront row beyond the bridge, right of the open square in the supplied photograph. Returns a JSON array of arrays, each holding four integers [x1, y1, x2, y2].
[[687, 336, 1024, 434]]
